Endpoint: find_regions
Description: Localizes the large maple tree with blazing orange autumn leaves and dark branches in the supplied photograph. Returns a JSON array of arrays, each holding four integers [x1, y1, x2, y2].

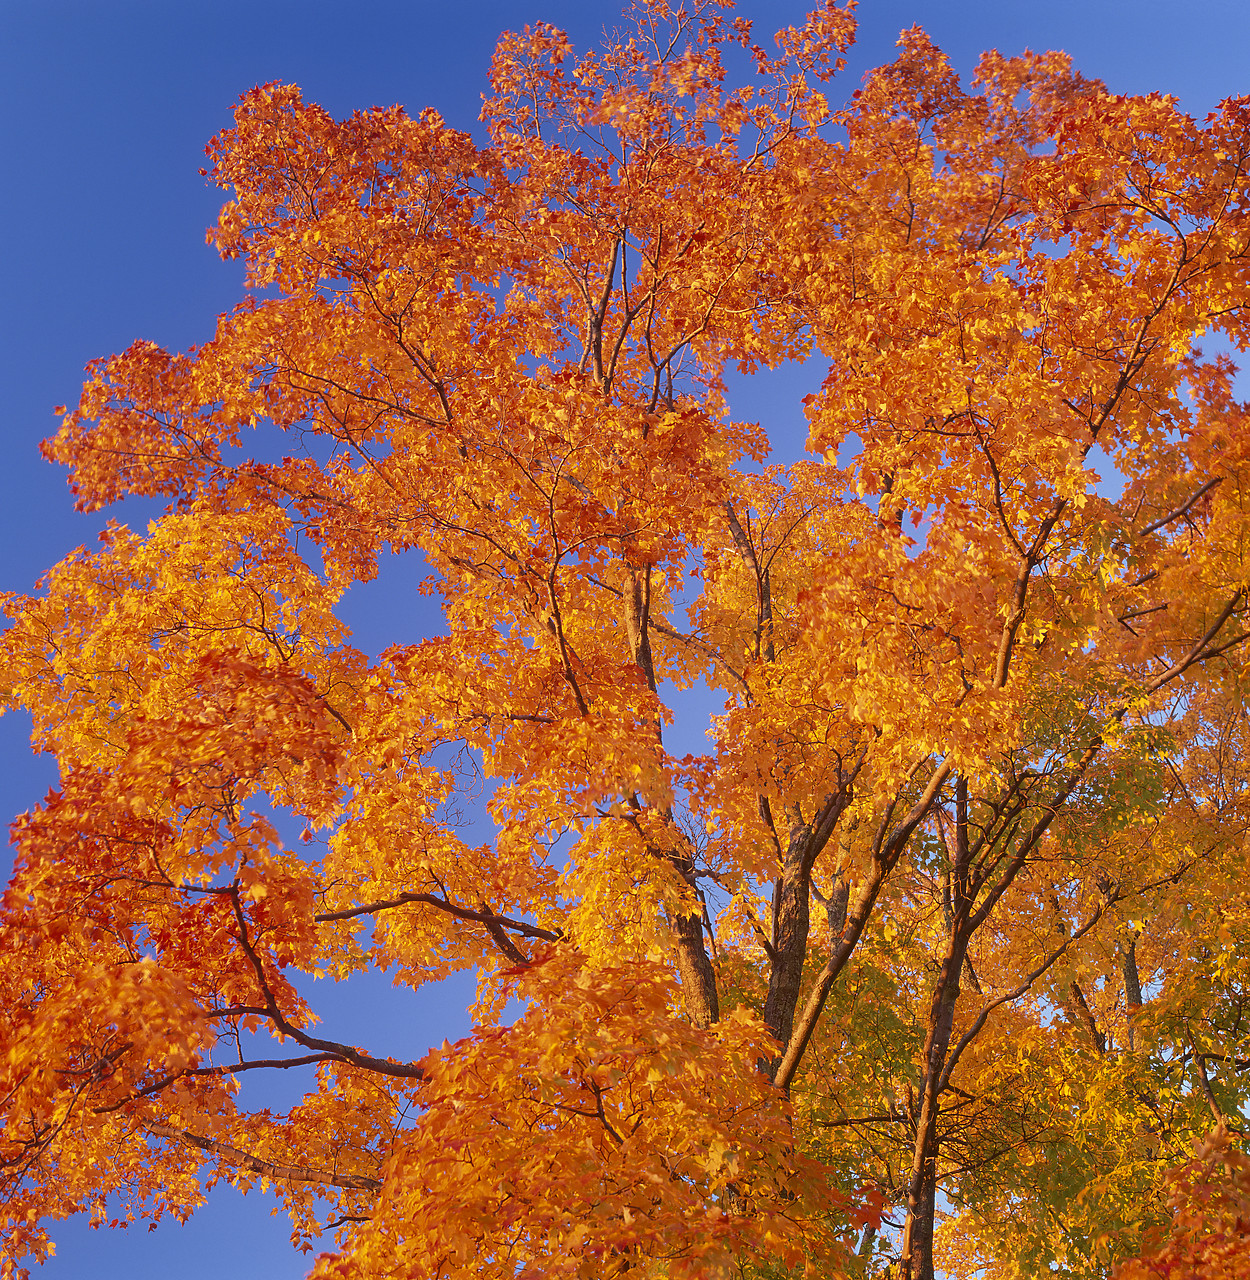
[[0, 0, 1250, 1280]]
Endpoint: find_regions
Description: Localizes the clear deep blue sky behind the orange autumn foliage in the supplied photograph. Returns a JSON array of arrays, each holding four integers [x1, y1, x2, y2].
[[0, 0, 1250, 1280]]
